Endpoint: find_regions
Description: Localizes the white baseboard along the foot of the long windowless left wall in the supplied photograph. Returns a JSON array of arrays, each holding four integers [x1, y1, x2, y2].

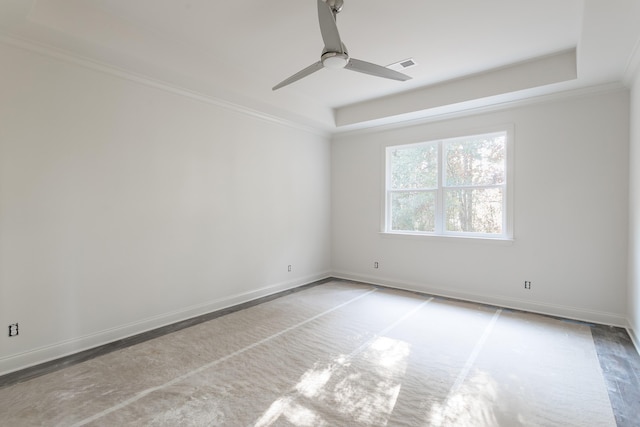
[[0, 272, 330, 376]]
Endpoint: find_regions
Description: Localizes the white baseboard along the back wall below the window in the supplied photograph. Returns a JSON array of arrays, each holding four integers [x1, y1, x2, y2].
[[332, 271, 628, 328]]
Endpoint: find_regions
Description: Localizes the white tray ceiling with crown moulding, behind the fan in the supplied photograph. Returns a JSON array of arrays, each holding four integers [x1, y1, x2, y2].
[[0, 0, 640, 132]]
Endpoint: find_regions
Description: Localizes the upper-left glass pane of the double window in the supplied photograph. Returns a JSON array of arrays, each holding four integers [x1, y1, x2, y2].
[[390, 144, 438, 189]]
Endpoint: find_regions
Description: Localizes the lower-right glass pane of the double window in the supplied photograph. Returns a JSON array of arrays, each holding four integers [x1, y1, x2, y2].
[[445, 188, 503, 234]]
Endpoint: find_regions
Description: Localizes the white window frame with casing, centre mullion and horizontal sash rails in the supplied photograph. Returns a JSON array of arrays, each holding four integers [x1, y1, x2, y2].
[[381, 125, 514, 241]]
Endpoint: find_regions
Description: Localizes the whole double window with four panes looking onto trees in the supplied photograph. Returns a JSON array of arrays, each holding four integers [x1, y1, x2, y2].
[[384, 131, 511, 239]]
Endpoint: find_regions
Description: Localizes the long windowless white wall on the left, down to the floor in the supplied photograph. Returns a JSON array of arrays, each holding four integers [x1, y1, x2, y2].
[[0, 44, 330, 374]]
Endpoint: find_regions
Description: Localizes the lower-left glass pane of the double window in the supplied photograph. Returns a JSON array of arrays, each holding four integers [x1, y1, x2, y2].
[[391, 191, 436, 231]]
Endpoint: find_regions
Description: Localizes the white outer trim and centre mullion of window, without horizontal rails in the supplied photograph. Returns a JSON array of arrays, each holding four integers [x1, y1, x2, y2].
[[380, 124, 515, 242]]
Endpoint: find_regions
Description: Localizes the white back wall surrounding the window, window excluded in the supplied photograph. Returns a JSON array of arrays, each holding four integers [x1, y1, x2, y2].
[[332, 89, 629, 325]]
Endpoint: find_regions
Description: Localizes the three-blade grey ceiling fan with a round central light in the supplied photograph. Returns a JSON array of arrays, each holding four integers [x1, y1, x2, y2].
[[273, 0, 411, 90]]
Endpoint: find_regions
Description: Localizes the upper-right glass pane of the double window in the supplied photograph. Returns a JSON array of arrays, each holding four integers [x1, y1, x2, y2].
[[444, 134, 506, 186]]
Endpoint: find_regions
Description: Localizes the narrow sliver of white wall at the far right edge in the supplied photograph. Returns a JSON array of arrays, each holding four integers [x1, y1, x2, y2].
[[628, 69, 640, 352]]
